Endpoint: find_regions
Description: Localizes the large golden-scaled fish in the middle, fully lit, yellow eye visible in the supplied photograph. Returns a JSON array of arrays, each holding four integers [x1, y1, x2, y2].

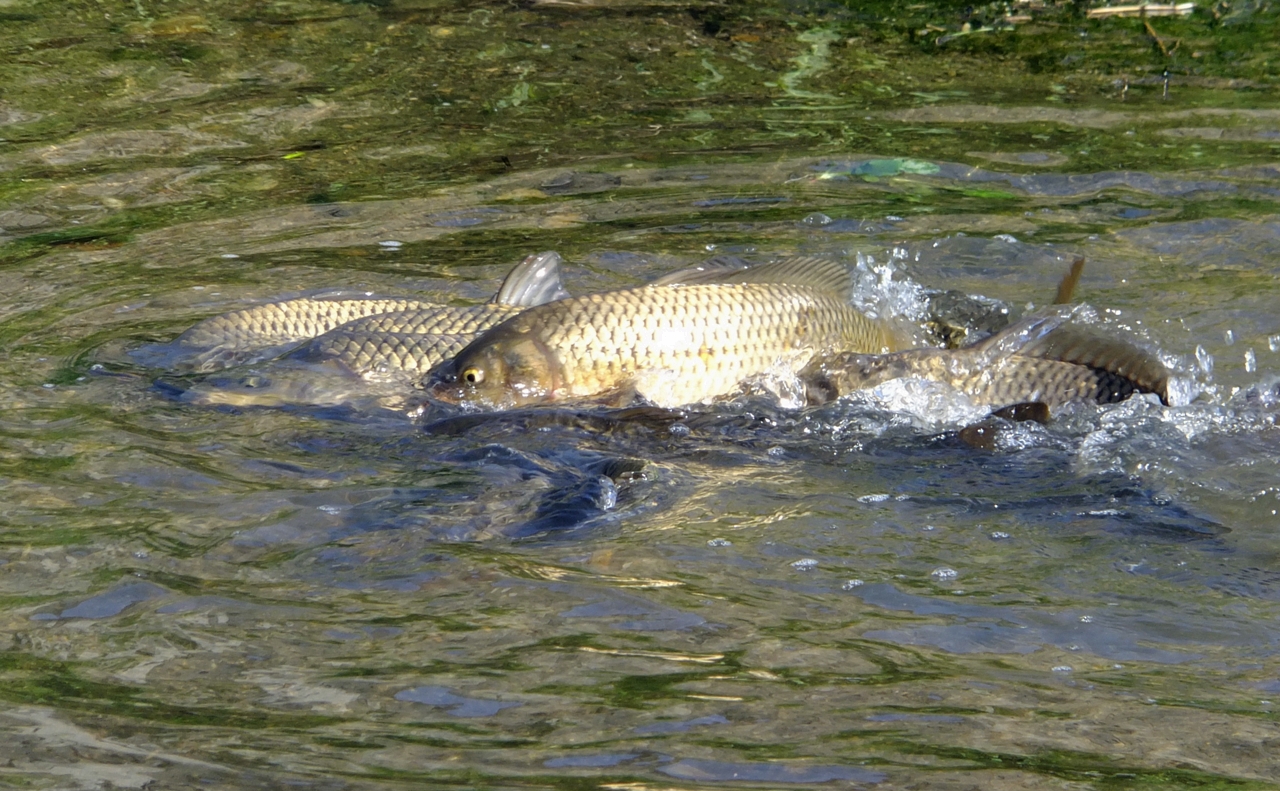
[[426, 259, 901, 408]]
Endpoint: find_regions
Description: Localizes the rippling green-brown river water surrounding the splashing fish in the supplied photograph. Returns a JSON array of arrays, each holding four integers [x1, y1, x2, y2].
[[0, 0, 1280, 788]]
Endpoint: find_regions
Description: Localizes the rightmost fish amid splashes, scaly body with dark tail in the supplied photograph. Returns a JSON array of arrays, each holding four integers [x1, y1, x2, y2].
[[800, 307, 1169, 408]]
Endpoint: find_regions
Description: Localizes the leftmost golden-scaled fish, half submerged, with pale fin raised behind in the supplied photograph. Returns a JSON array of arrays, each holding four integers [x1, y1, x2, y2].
[[154, 252, 567, 371]]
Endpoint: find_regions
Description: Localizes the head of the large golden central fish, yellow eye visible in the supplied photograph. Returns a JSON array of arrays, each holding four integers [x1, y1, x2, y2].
[[425, 328, 562, 410]]
